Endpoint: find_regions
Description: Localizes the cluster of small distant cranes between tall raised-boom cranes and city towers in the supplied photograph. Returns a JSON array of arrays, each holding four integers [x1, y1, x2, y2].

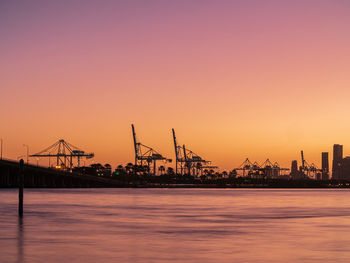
[[234, 158, 289, 178]]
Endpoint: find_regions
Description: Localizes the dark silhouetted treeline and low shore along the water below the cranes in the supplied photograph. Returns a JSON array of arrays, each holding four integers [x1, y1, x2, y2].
[[69, 163, 350, 188]]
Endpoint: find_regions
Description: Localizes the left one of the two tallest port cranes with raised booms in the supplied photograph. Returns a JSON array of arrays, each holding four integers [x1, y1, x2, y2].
[[131, 124, 172, 175]]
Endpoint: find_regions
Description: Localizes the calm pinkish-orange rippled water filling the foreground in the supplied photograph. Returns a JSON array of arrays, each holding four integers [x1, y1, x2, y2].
[[0, 189, 350, 263]]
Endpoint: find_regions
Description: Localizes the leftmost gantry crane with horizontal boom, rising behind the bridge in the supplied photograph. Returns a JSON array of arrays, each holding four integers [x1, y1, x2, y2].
[[30, 139, 94, 170]]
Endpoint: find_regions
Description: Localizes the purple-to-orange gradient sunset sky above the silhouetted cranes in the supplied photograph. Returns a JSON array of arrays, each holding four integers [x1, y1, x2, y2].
[[0, 0, 350, 169]]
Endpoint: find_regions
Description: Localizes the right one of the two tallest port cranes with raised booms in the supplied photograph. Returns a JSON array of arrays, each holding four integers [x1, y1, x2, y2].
[[172, 129, 218, 176]]
